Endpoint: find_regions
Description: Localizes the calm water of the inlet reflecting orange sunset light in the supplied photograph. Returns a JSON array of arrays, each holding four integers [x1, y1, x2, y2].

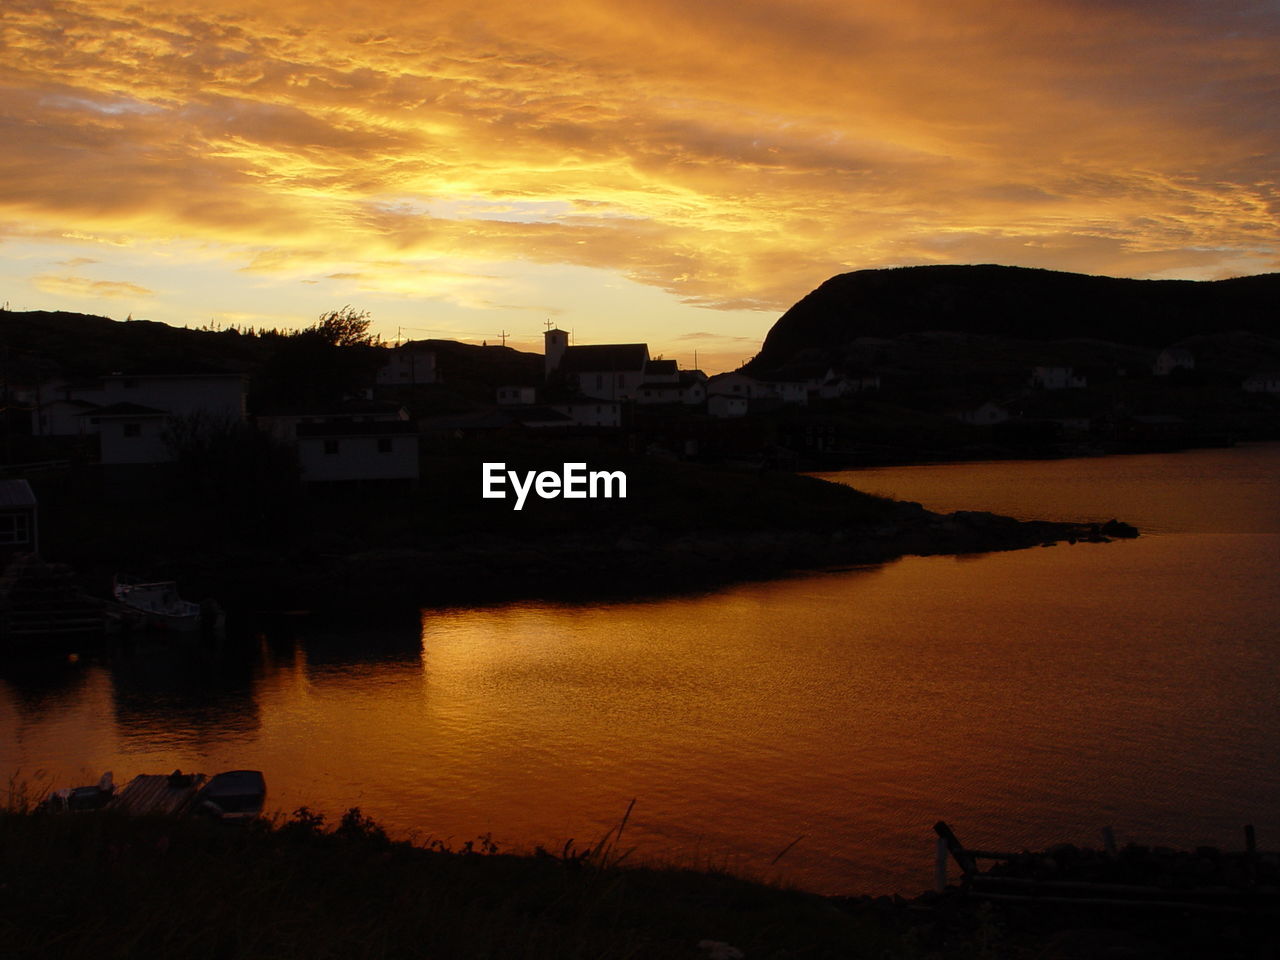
[[0, 445, 1280, 893]]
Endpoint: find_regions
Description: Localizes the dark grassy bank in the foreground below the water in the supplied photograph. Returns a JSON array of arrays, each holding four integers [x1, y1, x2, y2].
[[0, 810, 1276, 960]]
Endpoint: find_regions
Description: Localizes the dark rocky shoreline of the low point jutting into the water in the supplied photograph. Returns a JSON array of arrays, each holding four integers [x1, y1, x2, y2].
[[165, 500, 1138, 616]]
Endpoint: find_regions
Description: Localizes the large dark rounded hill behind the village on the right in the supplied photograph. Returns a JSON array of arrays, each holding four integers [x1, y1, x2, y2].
[[746, 265, 1280, 372]]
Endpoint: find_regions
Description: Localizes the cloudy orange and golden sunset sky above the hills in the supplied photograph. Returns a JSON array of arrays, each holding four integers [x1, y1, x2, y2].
[[0, 0, 1280, 371]]
